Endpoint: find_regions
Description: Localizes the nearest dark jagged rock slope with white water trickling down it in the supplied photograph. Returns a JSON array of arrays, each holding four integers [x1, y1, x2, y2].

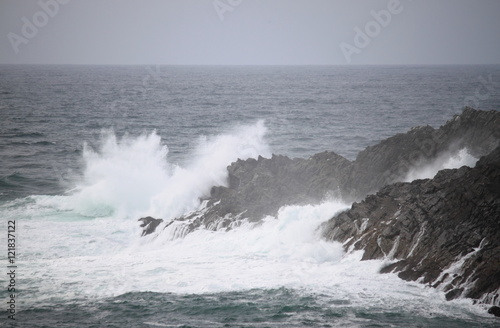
[[322, 147, 500, 305]]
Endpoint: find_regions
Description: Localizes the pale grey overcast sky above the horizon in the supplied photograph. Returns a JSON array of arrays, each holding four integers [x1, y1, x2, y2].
[[0, 0, 500, 65]]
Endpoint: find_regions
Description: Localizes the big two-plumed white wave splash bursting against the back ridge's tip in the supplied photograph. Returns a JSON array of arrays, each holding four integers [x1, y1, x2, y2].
[[57, 121, 269, 218]]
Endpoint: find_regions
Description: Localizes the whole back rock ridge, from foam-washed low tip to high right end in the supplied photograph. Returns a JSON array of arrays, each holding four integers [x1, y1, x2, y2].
[[141, 108, 500, 234]]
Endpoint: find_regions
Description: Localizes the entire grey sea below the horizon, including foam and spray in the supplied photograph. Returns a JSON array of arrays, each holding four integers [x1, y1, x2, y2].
[[0, 65, 500, 327]]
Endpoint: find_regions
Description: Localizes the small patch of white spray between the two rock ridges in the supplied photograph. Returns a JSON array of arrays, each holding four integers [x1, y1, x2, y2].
[[403, 148, 478, 182]]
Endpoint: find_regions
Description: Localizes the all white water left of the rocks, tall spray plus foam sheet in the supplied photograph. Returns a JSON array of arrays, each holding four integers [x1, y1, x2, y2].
[[0, 127, 492, 322]]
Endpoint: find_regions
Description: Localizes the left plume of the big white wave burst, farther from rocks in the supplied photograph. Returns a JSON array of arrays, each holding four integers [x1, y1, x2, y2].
[[44, 131, 172, 218]]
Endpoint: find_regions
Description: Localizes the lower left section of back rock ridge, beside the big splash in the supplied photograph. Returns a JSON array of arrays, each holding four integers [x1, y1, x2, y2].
[[186, 152, 350, 229]]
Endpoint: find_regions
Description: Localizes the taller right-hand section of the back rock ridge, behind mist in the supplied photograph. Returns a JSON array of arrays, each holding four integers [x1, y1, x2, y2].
[[342, 107, 500, 200]]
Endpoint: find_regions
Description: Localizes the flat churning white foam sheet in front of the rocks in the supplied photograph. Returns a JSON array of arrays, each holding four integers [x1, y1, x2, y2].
[[13, 195, 490, 316]]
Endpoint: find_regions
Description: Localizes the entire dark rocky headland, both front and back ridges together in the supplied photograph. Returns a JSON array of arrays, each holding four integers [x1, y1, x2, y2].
[[140, 108, 500, 305]]
